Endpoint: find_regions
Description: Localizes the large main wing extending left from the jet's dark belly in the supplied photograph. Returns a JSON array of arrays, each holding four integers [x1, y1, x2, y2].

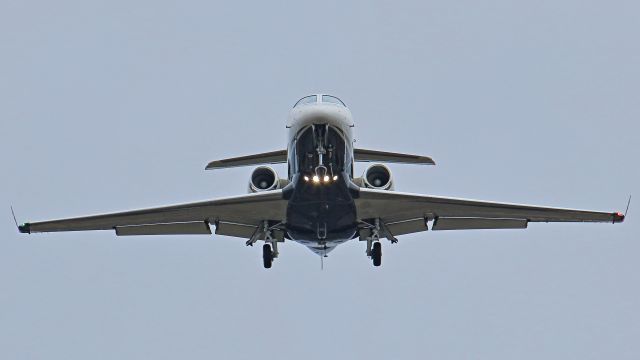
[[19, 190, 287, 237]]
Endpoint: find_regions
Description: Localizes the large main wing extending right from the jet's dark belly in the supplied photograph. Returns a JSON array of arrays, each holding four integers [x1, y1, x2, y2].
[[356, 188, 624, 235]]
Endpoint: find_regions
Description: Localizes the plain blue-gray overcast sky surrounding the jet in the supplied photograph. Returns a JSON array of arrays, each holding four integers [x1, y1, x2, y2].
[[0, 0, 640, 359]]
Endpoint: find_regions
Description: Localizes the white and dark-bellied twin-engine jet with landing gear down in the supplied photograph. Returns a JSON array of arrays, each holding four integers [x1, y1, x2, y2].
[[16, 94, 625, 268]]
